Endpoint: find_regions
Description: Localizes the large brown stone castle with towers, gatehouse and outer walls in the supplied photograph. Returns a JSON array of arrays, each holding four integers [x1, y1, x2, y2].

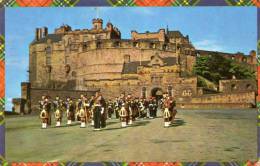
[[13, 18, 257, 114]]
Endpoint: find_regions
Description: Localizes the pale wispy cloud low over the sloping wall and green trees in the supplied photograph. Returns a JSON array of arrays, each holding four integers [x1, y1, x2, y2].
[[193, 39, 225, 51]]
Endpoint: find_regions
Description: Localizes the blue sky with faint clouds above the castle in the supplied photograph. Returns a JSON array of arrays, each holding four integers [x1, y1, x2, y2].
[[5, 7, 257, 110]]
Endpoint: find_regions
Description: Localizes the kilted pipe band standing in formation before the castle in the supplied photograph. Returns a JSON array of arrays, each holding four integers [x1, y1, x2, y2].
[[39, 92, 177, 130]]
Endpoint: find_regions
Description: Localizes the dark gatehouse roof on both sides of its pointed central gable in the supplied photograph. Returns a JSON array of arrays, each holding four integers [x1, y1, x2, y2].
[[122, 57, 177, 74]]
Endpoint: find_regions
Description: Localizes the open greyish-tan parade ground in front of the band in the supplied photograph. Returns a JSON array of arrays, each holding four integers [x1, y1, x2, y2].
[[6, 110, 257, 161]]
